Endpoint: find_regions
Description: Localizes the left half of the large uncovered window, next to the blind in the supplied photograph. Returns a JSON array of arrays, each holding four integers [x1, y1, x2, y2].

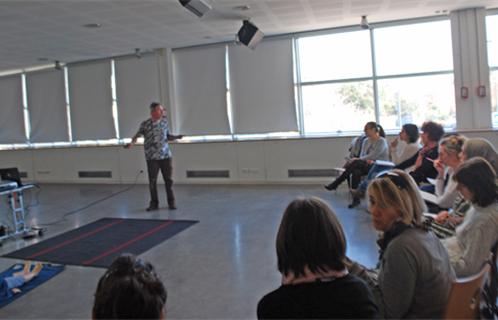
[[297, 30, 375, 135]]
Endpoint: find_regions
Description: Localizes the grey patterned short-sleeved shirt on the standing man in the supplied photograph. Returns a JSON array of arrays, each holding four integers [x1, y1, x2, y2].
[[135, 117, 171, 160]]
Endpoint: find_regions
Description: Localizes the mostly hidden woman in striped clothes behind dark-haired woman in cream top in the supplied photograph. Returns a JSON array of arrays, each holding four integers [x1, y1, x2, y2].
[[429, 138, 498, 238]]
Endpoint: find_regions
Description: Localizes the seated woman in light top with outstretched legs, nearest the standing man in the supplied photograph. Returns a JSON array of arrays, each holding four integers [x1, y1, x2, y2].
[[325, 122, 389, 191]]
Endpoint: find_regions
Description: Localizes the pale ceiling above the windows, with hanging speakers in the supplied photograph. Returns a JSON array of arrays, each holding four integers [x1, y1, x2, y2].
[[0, 0, 498, 71]]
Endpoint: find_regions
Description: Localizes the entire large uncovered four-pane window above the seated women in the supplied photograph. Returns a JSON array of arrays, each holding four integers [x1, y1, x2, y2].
[[297, 20, 456, 135]]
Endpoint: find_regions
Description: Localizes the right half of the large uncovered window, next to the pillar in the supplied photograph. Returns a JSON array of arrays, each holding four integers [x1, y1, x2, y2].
[[373, 20, 456, 130]]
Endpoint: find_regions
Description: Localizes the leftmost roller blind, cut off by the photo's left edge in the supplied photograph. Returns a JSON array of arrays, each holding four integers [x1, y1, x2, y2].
[[0, 74, 26, 144]]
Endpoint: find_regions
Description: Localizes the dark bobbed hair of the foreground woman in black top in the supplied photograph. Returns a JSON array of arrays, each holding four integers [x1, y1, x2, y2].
[[276, 197, 346, 277]]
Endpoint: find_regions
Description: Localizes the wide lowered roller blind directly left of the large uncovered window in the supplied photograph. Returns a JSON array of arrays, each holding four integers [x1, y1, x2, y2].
[[229, 39, 298, 134]]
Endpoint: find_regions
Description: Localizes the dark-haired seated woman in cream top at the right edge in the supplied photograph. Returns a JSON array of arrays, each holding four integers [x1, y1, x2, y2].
[[443, 157, 498, 277]]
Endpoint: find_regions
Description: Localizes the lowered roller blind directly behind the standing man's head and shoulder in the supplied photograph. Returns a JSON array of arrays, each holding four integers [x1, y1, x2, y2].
[[115, 54, 160, 138]]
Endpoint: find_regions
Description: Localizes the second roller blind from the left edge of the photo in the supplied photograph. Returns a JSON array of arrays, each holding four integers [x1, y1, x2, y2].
[[26, 70, 69, 142]]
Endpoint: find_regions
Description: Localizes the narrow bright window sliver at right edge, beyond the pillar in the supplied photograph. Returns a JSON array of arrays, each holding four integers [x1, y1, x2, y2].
[[486, 15, 498, 128]]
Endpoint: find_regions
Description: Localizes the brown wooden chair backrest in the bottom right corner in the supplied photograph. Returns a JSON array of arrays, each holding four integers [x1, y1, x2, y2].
[[444, 263, 490, 319]]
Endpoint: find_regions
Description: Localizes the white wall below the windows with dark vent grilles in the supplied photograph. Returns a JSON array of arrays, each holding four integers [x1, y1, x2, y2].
[[0, 131, 498, 184]]
